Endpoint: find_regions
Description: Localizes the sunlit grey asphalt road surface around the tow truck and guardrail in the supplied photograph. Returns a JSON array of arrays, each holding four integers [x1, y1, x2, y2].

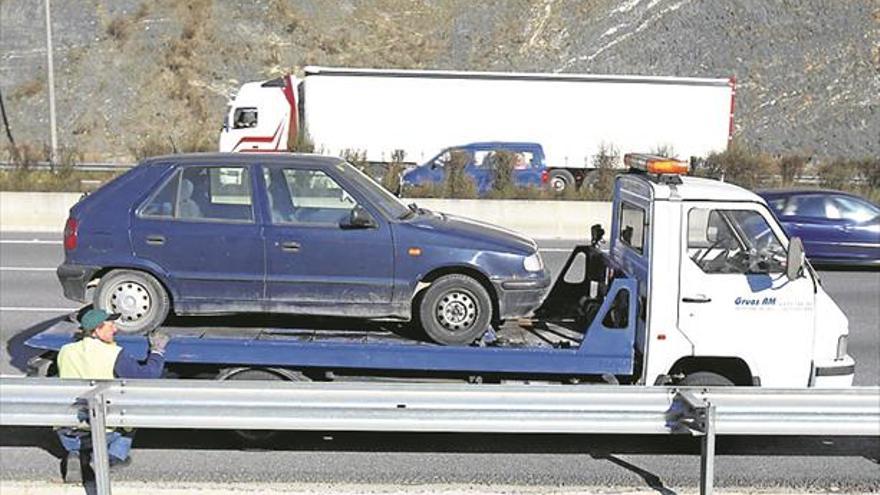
[[0, 233, 880, 493]]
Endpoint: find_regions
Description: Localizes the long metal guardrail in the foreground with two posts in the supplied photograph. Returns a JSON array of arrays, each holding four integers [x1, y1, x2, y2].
[[0, 377, 880, 493]]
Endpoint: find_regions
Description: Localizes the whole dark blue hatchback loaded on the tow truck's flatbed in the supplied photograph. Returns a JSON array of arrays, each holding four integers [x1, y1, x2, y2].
[[58, 153, 550, 344]]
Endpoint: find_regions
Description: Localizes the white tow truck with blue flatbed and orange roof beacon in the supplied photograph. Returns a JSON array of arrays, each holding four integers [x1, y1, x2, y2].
[[26, 154, 855, 388]]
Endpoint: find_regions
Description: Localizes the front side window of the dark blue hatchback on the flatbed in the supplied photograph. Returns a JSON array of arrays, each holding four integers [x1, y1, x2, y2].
[[263, 167, 357, 226]]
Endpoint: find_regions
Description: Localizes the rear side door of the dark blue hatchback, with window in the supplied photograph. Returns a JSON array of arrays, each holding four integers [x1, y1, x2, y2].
[[131, 163, 265, 312]]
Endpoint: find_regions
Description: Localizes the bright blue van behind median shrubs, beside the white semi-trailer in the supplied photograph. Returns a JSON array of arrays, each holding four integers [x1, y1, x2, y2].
[[401, 141, 587, 195]]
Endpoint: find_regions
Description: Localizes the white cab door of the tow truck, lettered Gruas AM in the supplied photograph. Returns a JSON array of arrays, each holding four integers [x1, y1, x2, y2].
[[679, 202, 815, 387]]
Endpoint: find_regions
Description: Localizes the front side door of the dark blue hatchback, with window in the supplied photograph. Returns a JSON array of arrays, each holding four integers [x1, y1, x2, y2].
[[262, 165, 394, 316]]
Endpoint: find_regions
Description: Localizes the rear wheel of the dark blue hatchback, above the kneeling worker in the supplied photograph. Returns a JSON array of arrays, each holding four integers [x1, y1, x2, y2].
[[94, 270, 171, 334]]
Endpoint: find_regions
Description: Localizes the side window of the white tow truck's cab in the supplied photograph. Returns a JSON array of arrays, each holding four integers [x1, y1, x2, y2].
[[687, 208, 786, 274]]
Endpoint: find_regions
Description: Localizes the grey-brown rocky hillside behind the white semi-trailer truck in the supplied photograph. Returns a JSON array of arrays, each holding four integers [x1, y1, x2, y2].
[[0, 0, 880, 160]]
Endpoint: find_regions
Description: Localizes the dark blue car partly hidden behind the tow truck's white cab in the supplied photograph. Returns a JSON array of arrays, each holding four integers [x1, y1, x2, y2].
[[758, 189, 880, 266]]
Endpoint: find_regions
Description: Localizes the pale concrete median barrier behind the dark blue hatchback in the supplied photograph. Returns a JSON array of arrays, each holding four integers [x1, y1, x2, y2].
[[0, 192, 611, 239]]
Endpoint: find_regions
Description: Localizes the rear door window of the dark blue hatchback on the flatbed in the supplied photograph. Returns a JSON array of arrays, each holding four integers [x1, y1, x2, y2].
[[175, 166, 254, 222]]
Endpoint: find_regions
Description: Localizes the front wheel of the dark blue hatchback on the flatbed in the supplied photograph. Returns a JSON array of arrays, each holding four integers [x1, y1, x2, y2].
[[418, 275, 492, 345]]
